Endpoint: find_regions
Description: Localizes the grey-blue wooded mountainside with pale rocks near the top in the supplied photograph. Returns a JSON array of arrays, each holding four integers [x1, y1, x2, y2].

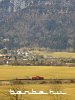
[[0, 0, 75, 50]]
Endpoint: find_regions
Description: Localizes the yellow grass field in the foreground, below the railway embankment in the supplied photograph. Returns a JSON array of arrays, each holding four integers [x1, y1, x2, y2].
[[0, 84, 75, 100]]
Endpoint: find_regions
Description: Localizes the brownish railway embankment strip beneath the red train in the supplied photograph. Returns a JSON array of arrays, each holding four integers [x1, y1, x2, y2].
[[0, 79, 75, 85]]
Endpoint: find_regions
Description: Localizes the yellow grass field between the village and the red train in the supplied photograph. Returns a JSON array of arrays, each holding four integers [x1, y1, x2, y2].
[[0, 66, 75, 80]]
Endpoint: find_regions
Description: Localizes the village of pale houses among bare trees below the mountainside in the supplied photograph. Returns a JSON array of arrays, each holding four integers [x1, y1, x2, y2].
[[0, 48, 75, 66]]
